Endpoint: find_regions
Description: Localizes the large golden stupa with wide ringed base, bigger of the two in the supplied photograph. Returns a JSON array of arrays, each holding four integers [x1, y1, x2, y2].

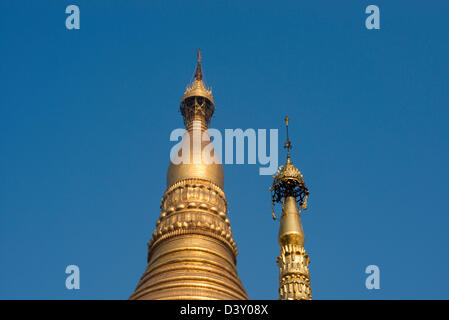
[[130, 53, 248, 300]]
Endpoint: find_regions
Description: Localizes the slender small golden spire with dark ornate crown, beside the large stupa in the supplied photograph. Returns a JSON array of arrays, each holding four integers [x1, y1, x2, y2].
[[270, 117, 312, 300]]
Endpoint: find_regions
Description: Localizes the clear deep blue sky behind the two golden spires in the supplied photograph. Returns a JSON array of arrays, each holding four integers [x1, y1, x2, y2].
[[0, 0, 449, 299]]
